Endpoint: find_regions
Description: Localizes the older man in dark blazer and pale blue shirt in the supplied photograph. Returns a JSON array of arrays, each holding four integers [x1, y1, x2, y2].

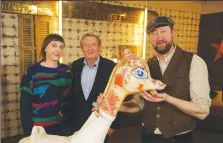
[[72, 33, 119, 142]]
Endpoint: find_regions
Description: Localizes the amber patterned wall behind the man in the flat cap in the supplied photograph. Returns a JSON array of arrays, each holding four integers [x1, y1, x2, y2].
[[95, 1, 201, 59]]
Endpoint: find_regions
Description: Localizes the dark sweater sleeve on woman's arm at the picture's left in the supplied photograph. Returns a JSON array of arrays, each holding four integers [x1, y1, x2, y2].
[[20, 73, 33, 136]]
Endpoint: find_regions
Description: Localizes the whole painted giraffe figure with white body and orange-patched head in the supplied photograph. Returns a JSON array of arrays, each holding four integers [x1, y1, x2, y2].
[[19, 52, 165, 143]]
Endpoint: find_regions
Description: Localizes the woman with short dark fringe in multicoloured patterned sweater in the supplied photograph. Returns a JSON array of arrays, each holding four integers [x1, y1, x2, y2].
[[20, 34, 72, 136]]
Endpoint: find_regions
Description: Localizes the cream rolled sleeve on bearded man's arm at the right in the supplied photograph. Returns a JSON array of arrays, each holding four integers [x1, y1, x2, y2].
[[190, 54, 211, 114]]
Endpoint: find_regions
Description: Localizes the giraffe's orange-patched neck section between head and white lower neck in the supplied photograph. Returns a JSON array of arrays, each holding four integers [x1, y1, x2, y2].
[[99, 85, 127, 116]]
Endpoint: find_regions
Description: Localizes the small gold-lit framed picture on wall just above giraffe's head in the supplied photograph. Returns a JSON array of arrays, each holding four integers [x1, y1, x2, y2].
[[118, 45, 139, 59]]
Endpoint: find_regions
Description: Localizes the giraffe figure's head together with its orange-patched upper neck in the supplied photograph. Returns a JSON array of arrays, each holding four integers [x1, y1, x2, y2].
[[100, 54, 165, 115]]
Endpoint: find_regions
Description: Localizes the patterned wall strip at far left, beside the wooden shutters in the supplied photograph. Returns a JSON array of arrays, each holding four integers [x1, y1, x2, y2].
[[1, 13, 22, 138]]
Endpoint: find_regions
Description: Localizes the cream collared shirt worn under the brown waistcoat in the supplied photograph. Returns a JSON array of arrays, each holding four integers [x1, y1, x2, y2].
[[139, 45, 211, 134]]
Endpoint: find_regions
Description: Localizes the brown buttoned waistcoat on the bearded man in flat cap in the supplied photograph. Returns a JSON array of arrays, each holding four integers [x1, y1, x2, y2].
[[143, 46, 195, 137]]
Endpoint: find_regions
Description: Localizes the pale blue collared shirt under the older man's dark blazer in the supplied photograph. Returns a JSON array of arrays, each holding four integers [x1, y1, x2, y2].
[[81, 56, 100, 100]]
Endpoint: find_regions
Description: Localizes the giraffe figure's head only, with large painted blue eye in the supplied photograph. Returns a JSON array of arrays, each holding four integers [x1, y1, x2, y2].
[[106, 54, 165, 95]]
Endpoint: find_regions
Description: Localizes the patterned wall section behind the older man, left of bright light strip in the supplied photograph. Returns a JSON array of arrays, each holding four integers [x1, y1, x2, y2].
[[63, 18, 143, 64]]
